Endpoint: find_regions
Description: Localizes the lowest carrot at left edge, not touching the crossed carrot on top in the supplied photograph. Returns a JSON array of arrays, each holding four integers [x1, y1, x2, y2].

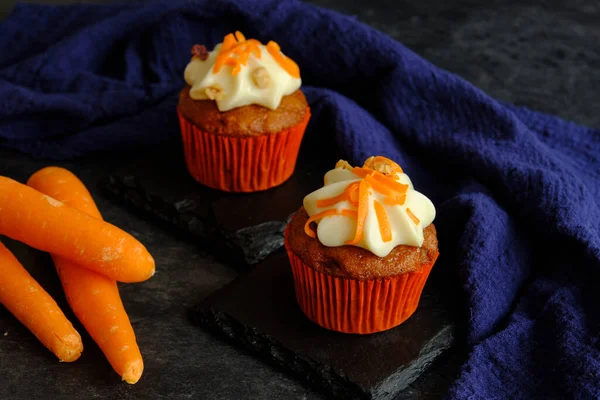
[[0, 239, 83, 362]]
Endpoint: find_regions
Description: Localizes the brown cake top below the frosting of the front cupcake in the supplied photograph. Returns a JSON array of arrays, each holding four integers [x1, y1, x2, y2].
[[287, 207, 438, 280]]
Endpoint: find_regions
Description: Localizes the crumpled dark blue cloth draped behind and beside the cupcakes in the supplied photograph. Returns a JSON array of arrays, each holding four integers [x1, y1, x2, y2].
[[0, 0, 600, 398]]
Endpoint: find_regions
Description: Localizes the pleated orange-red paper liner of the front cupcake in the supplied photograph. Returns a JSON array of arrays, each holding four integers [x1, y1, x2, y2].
[[284, 231, 437, 334]]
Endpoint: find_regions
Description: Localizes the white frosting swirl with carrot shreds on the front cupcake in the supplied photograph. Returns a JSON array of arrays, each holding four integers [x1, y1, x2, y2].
[[304, 156, 435, 257]]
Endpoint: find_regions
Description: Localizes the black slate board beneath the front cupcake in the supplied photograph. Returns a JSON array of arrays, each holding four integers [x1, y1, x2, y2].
[[190, 251, 454, 399]]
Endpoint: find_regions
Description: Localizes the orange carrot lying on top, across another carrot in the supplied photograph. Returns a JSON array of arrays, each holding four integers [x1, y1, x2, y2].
[[0, 177, 154, 282]]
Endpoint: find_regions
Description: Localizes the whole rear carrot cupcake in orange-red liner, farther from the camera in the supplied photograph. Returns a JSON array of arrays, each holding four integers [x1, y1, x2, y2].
[[177, 32, 310, 192]]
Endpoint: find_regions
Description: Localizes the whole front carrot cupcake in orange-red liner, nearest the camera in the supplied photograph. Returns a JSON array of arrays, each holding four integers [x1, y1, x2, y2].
[[285, 157, 439, 334]]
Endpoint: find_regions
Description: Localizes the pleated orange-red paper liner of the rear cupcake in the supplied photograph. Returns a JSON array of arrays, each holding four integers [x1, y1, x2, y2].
[[177, 108, 310, 192]]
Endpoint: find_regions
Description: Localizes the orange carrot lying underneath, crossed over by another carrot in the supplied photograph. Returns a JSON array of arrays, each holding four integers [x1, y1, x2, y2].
[[27, 167, 144, 384]]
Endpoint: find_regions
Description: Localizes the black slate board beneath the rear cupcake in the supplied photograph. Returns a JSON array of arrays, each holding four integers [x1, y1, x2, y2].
[[99, 140, 337, 264]]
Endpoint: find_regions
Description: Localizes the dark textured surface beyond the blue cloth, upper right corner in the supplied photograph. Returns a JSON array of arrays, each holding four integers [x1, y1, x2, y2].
[[309, 0, 600, 128]]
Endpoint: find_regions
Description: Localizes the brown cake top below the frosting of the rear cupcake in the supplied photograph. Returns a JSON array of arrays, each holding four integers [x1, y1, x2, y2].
[[178, 86, 308, 136]]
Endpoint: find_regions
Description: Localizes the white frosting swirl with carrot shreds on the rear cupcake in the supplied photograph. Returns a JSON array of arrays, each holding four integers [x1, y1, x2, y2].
[[184, 32, 302, 112]]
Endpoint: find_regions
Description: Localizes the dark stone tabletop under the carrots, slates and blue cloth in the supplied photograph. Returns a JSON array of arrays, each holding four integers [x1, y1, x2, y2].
[[0, 0, 600, 400]]
